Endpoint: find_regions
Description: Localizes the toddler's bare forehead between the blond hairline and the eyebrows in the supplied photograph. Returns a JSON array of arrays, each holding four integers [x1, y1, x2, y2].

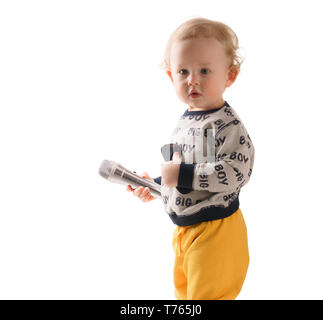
[[170, 38, 226, 65]]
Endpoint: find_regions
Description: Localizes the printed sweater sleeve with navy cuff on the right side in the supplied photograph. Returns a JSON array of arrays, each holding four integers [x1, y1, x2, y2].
[[178, 120, 254, 192]]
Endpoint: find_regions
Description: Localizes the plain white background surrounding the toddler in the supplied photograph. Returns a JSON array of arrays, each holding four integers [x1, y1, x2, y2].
[[0, 0, 323, 299]]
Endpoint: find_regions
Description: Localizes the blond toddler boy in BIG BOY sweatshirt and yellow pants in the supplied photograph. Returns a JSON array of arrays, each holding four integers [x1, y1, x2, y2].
[[127, 18, 254, 300]]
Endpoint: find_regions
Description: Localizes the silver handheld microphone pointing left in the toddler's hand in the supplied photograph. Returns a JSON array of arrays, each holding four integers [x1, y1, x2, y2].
[[99, 160, 161, 199]]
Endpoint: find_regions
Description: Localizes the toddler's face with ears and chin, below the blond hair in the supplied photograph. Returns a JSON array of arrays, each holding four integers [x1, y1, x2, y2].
[[167, 38, 238, 110]]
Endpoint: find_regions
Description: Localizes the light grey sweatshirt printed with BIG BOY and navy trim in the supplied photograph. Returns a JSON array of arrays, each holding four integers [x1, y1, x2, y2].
[[154, 102, 254, 226]]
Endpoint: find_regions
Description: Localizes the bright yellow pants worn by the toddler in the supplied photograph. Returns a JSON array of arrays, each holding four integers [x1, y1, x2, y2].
[[173, 209, 249, 300]]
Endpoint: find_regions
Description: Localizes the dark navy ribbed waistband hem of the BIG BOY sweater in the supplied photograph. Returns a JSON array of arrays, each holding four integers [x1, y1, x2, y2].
[[169, 198, 239, 226]]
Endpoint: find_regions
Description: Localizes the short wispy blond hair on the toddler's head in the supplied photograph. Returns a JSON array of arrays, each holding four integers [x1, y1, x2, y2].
[[161, 18, 244, 71]]
